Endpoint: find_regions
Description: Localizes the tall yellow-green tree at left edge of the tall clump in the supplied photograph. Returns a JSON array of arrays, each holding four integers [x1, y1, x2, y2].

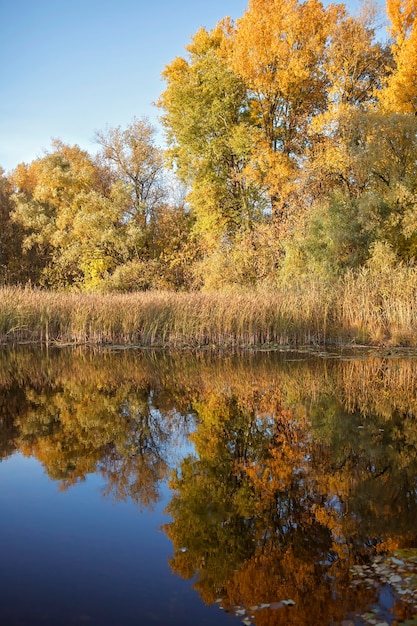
[[158, 22, 264, 253]]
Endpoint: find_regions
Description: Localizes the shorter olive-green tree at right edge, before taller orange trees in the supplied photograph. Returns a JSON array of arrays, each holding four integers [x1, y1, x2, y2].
[[284, 110, 417, 277]]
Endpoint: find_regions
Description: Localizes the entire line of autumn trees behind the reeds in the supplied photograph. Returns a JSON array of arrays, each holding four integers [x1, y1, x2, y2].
[[0, 0, 417, 291]]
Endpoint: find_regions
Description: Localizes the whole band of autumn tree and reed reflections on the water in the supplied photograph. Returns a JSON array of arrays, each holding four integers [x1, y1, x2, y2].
[[0, 351, 417, 625]]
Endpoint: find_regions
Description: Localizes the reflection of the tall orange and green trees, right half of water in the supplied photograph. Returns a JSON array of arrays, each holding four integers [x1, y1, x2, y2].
[[160, 354, 417, 624]]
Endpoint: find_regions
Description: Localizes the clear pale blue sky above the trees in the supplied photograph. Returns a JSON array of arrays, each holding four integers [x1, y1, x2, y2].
[[0, 0, 380, 171]]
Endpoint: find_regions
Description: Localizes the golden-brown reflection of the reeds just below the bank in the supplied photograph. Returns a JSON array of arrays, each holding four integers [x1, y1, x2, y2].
[[0, 349, 417, 416]]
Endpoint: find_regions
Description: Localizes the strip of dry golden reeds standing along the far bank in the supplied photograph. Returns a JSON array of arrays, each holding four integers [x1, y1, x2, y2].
[[0, 273, 417, 348]]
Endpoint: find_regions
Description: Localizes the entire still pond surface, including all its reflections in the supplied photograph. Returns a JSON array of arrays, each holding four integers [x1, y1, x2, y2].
[[0, 347, 417, 626]]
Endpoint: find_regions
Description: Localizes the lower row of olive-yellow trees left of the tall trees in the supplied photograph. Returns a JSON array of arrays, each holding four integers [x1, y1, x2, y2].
[[0, 119, 191, 291]]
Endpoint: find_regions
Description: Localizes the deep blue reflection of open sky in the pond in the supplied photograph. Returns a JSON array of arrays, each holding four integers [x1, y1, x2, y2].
[[0, 454, 230, 626]]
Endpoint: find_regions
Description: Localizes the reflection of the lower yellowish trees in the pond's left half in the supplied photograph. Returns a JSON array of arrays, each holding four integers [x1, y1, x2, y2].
[[16, 383, 188, 506]]
